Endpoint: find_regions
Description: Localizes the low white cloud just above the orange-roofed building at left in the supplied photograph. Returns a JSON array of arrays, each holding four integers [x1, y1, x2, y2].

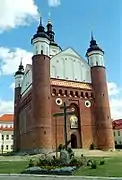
[[0, 99, 14, 115]]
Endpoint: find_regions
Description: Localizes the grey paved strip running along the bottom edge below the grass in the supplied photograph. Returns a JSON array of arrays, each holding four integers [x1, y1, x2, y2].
[[0, 175, 122, 180]]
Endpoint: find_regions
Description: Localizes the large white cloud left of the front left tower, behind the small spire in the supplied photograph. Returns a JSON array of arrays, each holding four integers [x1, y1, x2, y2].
[[0, 47, 32, 75]]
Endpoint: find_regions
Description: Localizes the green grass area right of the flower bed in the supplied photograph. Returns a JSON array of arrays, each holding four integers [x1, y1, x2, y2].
[[75, 156, 122, 177]]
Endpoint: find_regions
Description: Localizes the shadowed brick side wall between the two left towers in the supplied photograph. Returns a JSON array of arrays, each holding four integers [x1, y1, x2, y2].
[[19, 90, 34, 150]]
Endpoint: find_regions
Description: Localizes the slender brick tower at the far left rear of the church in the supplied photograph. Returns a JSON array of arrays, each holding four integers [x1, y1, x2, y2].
[[14, 61, 24, 151]]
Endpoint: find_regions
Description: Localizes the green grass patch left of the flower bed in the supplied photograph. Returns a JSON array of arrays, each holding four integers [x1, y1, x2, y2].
[[0, 161, 28, 173]]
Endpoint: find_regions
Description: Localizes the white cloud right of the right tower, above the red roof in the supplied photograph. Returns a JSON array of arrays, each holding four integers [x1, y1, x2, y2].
[[108, 82, 122, 119]]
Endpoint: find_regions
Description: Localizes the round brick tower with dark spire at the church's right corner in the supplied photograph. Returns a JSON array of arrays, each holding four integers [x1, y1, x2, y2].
[[86, 35, 114, 150]]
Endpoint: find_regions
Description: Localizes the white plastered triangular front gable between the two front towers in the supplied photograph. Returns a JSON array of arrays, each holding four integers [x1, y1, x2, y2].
[[50, 48, 91, 83]]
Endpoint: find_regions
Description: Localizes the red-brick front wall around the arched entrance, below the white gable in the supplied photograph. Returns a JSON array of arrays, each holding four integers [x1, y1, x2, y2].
[[51, 86, 95, 149]]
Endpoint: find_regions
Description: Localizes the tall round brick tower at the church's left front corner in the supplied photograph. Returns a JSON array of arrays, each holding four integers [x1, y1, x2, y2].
[[31, 18, 52, 152]]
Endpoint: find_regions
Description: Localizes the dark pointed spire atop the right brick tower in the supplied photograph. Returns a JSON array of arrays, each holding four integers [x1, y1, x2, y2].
[[86, 31, 104, 54]]
